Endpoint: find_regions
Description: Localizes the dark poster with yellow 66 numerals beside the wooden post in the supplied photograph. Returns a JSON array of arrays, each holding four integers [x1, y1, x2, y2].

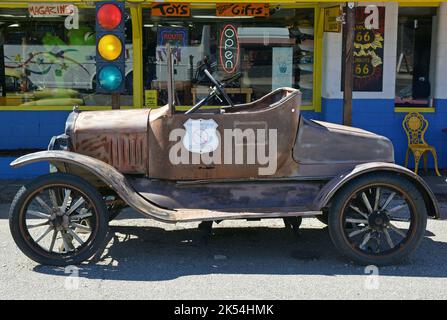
[[341, 6, 385, 92]]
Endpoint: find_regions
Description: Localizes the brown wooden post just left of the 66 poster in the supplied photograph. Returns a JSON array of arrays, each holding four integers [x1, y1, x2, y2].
[[343, 2, 355, 126]]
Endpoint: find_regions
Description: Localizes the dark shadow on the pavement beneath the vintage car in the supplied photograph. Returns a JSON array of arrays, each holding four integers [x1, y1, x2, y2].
[[34, 226, 447, 281]]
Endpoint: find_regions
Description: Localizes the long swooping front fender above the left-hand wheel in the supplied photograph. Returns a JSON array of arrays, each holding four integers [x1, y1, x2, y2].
[[10, 150, 177, 222]]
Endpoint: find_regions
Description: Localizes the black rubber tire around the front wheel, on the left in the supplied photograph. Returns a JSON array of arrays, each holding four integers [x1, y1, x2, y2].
[[9, 173, 109, 266]]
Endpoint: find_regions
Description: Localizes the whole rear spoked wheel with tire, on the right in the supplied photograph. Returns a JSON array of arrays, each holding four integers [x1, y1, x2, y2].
[[328, 174, 427, 265]]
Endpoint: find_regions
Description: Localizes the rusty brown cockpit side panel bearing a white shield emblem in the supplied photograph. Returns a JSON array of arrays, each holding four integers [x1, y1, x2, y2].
[[149, 89, 299, 180]]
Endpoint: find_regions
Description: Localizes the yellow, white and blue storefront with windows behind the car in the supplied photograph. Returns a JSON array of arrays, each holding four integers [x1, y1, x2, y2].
[[0, 0, 447, 177]]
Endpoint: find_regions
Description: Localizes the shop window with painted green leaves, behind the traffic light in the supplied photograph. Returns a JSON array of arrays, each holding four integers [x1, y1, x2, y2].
[[0, 8, 133, 109]]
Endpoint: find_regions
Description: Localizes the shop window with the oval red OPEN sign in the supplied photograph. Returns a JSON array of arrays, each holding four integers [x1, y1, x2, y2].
[[143, 6, 314, 107]]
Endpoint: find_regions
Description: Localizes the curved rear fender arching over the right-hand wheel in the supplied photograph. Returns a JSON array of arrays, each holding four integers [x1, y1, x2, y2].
[[313, 162, 439, 218]]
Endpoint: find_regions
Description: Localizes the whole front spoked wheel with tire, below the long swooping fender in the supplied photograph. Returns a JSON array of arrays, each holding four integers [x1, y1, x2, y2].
[[9, 173, 108, 266]]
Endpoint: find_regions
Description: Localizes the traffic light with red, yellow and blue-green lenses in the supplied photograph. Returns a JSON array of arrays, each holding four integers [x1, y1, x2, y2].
[[96, 1, 126, 93]]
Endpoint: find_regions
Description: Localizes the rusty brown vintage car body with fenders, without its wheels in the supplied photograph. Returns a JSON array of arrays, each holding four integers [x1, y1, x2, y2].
[[11, 50, 439, 263]]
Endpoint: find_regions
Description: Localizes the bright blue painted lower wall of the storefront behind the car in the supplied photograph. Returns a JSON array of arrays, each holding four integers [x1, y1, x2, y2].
[[0, 104, 447, 179]]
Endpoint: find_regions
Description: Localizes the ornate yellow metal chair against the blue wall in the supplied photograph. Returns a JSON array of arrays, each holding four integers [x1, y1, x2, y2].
[[402, 112, 441, 176]]
